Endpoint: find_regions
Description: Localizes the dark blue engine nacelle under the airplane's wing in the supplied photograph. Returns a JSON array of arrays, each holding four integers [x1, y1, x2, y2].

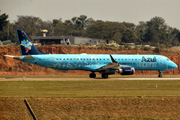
[[118, 67, 135, 75]]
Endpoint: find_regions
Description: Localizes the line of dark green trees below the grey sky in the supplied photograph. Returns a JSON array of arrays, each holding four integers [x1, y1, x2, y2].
[[0, 13, 180, 47]]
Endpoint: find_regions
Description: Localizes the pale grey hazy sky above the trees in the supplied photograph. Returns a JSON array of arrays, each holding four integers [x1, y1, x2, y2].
[[0, 0, 180, 30]]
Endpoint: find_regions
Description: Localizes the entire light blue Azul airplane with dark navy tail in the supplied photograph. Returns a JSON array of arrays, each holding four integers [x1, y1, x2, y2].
[[4, 30, 178, 78]]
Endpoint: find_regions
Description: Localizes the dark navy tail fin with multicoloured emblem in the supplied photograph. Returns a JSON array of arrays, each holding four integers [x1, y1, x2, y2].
[[16, 30, 45, 55]]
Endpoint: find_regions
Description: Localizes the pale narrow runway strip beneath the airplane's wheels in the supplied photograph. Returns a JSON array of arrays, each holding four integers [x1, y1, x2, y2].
[[0, 78, 180, 81]]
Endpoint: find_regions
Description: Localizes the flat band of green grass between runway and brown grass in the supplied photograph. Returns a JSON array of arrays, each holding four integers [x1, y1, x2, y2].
[[0, 80, 180, 98]]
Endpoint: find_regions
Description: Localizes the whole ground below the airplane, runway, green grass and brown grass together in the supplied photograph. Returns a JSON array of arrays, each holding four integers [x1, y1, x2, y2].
[[0, 75, 180, 120]]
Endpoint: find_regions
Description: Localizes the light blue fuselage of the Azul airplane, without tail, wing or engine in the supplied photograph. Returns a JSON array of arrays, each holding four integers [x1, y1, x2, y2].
[[22, 54, 177, 72]]
